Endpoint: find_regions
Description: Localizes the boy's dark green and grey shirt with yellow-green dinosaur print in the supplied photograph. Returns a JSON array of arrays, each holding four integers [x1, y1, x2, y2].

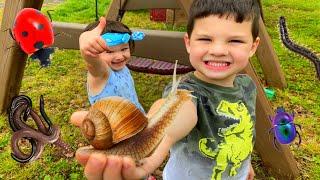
[[163, 72, 256, 180]]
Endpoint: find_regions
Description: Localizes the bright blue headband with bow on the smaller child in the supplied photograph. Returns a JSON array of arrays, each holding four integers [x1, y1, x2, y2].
[[101, 31, 145, 46]]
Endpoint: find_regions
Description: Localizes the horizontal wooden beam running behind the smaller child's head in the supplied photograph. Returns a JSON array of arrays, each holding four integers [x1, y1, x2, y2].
[[52, 22, 189, 65]]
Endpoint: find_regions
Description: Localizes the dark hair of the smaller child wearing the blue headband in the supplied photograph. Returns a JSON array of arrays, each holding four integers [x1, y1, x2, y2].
[[84, 20, 134, 52]]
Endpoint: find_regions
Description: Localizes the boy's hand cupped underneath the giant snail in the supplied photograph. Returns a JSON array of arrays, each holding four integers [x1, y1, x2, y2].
[[70, 111, 162, 180]]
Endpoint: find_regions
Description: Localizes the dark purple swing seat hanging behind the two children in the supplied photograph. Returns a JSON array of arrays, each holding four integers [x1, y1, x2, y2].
[[127, 56, 194, 75]]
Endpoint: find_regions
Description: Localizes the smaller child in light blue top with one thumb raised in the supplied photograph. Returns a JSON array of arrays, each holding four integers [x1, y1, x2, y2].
[[71, 17, 144, 126]]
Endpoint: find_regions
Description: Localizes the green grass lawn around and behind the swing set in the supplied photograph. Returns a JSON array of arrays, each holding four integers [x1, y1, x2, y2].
[[0, 0, 320, 179]]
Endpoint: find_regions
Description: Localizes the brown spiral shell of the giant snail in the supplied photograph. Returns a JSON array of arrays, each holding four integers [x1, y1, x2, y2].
[[81, 97, 148, 150]]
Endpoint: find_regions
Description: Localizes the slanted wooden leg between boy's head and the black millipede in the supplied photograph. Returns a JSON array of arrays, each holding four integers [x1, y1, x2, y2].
[[256, 18, 287, 89]]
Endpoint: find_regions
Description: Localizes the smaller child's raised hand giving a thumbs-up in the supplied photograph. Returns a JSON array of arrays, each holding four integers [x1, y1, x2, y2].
[[79, 17, 108, 59]]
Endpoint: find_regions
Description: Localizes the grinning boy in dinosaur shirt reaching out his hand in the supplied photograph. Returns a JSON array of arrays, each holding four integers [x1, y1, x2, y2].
[[76, 0, 260, 180]]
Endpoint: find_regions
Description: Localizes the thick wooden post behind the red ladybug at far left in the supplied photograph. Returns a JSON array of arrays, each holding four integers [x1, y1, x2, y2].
[[0, 0, 43, 112]]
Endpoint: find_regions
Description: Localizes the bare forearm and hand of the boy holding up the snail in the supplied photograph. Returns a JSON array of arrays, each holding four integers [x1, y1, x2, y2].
[[76, 101, 197, 179]]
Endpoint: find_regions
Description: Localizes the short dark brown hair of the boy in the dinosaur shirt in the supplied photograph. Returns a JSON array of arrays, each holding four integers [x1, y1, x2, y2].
[[187, 0, 262, 39]]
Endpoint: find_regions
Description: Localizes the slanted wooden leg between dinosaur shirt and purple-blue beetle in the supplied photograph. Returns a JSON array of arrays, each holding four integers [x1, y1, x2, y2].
[[244, 63, 299, 179]]
